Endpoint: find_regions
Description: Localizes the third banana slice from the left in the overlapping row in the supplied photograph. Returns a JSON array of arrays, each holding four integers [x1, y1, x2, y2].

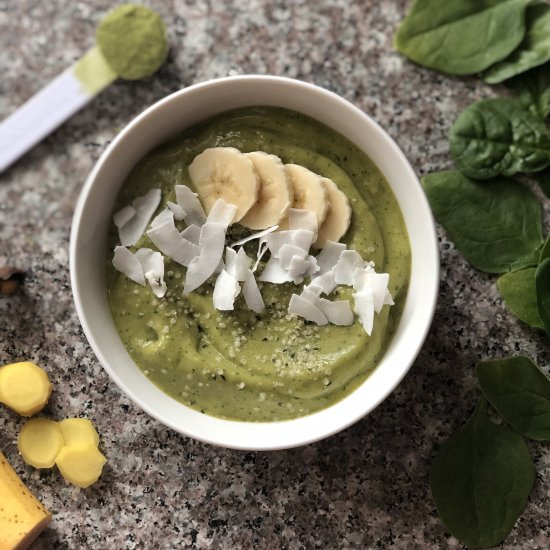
[[279, 164, 330, 229]]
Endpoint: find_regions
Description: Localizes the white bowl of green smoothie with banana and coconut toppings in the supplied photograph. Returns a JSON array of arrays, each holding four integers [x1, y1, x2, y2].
[[71, 76, 438, 449]]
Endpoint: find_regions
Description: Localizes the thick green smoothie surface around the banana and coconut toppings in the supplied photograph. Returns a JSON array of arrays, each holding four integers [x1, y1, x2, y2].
[[108, 107, 411, 421]]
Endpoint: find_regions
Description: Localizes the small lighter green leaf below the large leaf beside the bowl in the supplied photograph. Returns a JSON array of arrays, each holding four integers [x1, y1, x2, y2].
[[497, 267, 544, 329]]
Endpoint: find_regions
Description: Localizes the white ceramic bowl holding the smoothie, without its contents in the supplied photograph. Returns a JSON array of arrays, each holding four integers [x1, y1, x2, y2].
[[70, 76, 439, 450]]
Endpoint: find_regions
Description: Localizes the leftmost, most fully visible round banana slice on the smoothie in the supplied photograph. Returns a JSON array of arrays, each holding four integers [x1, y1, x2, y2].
[[189, 147, 260, 222]]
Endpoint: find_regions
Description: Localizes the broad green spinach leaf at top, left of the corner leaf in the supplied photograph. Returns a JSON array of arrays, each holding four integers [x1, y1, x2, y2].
[[394, 0, 529, 75]]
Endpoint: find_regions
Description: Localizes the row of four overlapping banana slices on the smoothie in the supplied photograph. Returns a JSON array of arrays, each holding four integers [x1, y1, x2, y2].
[[189, 147, 351, 248]]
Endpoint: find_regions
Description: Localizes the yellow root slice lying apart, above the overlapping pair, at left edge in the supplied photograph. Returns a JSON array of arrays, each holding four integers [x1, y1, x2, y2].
[[0, 361, 52, 416]]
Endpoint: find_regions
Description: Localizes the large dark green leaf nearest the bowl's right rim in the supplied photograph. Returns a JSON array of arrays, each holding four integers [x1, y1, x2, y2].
[[422, 171, 542, 273]]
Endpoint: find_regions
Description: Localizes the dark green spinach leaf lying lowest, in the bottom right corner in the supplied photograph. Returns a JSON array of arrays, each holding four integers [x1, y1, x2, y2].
[[430, 398, 534, 548]]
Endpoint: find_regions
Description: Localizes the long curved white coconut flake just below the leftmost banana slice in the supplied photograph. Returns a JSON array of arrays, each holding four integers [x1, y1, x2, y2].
[[183, 222, 227, 294]]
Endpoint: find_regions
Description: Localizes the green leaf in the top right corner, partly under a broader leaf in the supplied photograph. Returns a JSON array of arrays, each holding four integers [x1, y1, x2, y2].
[[483, 4, 550, 84]]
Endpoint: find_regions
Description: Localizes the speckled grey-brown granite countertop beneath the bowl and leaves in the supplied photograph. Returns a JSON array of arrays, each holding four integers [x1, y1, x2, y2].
[[0, 0, 550, 549]]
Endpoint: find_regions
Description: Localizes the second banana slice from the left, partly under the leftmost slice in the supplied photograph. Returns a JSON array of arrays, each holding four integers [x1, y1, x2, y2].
[[240, 151, 294, 229]]
